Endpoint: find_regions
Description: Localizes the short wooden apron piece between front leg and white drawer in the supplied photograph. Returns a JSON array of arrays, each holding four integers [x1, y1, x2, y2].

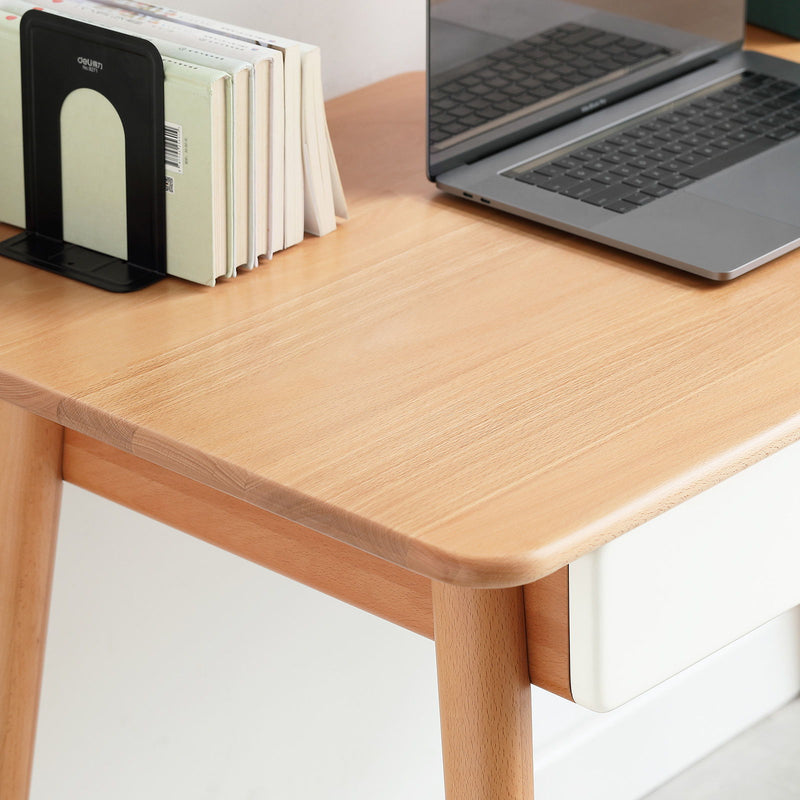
[[524, 567, 573, 701]]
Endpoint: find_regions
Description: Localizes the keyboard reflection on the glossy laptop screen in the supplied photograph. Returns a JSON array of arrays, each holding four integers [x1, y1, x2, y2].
[[429, 23, 671, 145]]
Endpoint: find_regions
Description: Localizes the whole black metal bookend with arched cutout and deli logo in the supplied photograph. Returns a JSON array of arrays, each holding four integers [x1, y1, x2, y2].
[[0, 10, 167, 292]]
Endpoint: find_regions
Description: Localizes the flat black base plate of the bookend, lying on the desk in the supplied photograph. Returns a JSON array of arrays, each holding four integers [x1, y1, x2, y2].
[[0, 231, 167, 292]]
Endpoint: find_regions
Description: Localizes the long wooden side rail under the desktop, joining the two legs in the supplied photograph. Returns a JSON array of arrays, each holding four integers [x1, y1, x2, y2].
[[64, 431, 433, 639]]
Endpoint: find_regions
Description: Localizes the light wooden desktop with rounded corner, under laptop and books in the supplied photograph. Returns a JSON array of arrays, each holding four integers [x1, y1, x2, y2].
[[0, 28, 800, 586]]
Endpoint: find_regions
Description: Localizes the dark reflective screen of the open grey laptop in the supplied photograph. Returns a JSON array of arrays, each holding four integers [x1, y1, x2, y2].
[[428, 0, 745, 176]]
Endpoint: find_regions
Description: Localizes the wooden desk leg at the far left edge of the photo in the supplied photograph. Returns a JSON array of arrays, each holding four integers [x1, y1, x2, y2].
[[0, 401, 63, 800]]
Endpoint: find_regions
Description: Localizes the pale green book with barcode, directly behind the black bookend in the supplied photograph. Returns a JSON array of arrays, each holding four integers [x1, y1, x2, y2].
[[0, 6, 230, 286]]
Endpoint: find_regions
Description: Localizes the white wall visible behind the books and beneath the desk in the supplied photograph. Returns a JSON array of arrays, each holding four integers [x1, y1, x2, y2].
[[25, 0, 800, 800]]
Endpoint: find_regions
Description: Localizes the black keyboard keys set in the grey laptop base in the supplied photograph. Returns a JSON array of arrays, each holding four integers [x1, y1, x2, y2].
[[504, 73, 800, 214]]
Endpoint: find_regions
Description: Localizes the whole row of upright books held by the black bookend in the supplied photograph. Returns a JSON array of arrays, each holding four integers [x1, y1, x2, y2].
[[0, 0, 347, 286]]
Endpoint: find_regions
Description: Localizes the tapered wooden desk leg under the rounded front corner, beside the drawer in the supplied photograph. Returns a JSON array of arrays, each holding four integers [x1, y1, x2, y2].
[[433, 581, 533, 800]]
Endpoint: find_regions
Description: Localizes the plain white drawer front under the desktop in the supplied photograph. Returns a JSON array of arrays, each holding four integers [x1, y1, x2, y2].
[[568, 443, 800, 711]]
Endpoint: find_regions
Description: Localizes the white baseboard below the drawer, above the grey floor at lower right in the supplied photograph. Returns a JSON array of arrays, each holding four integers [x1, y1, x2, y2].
[[534, 608, 800, 800]]
